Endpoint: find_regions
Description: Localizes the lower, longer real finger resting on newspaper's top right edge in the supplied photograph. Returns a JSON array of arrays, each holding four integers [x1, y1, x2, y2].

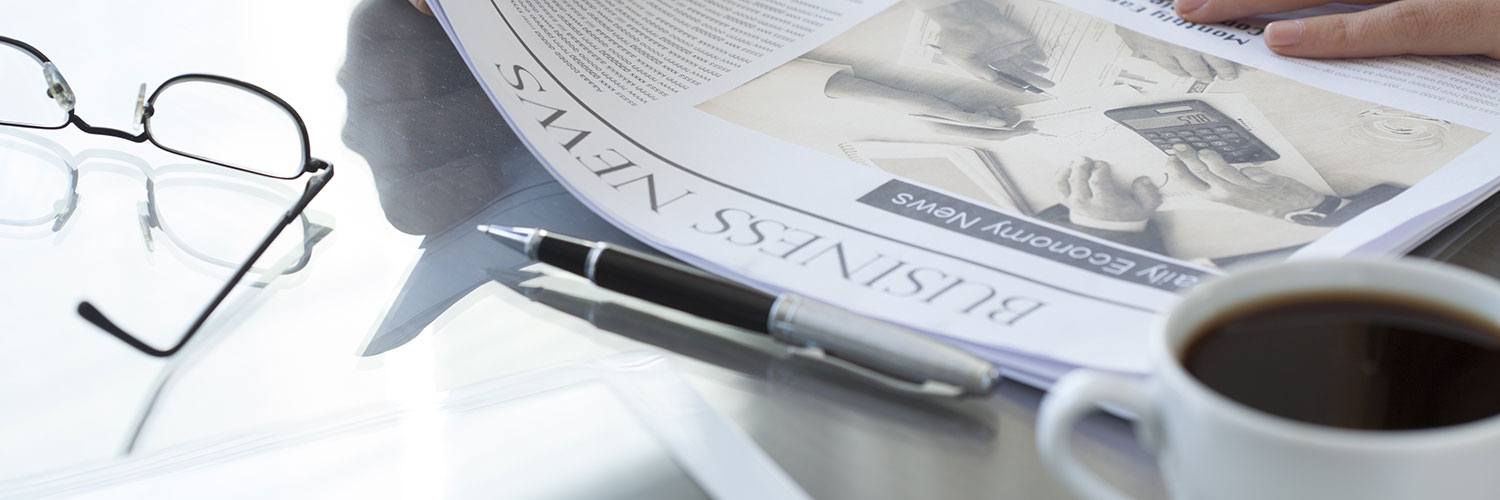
[[1266, 0, 1500, 57]]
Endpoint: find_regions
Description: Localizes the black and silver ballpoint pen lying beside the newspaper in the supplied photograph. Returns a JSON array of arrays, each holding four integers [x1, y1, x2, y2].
[[479, 225, 999, 395]]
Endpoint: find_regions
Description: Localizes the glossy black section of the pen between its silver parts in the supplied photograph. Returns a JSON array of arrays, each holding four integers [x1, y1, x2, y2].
[[585, 245, 776, 333]]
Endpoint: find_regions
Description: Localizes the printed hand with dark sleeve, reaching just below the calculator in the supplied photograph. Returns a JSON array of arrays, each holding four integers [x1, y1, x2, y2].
[[1167, 144, 1326, 219]]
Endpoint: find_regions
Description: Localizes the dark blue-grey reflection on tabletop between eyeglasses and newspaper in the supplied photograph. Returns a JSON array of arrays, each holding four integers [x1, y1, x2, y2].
[[339, 0, 644, 356]]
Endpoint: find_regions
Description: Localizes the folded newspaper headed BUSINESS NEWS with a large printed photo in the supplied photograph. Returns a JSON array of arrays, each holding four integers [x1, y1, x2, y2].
[[434, 0, 1500, 378]]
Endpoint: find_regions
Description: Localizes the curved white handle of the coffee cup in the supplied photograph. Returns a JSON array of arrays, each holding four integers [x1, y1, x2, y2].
[[1037, 369, 1158, 500]]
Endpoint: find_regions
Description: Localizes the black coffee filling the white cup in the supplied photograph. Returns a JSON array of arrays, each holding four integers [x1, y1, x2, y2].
[[1182, 294, 1500, 429]]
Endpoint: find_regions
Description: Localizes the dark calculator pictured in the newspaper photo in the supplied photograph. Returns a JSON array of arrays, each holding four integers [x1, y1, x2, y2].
[[1104, 99, 1281, 164]]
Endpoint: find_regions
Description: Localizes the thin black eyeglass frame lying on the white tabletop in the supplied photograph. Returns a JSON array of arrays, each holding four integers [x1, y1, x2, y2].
[[0, 36, 333, 357]]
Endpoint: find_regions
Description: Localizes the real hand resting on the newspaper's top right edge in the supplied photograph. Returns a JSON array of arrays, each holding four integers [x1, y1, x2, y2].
[[1178, 0, 1500, 59]]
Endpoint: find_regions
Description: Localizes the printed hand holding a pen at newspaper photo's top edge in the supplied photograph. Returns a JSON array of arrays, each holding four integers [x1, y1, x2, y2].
[[924, 0, 1055, 90]]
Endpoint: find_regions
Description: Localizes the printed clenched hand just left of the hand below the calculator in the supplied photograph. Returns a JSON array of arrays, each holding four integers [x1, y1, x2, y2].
[[1058, 158, 1161, 230]]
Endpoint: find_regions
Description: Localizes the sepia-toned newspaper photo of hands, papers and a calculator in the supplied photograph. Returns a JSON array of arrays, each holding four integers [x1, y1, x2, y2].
[[699, 0, 1488, 267]]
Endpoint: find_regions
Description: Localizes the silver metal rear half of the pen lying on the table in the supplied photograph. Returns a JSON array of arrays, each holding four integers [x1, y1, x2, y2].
[[771, 294, 999, 393]]
